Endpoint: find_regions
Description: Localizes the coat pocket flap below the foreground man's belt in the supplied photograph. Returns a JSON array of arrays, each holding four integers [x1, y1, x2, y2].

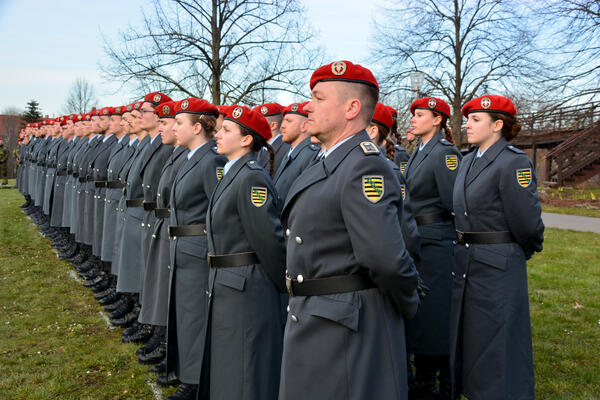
[[308, 292, 360, 331]]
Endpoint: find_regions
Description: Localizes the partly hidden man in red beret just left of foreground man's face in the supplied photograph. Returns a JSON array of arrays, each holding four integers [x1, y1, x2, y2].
[[273, 102, 319, 204]]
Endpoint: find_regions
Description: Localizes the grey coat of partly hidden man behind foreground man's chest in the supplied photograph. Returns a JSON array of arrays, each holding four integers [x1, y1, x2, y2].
[[273, 137, 319, 204]]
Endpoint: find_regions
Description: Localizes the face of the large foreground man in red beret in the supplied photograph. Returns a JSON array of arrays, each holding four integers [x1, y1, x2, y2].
[[304, 82, 346, 142]]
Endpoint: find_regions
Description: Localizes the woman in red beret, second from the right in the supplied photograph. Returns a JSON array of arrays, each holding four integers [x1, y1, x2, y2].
[[405, 97, 462, 399]]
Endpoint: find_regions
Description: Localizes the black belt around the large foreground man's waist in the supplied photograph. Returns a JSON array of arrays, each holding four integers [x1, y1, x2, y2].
[[285, 274, 376, 296]]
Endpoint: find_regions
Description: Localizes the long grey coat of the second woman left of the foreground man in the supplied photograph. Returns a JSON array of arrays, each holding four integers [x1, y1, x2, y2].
[[167, 141, 226, 383]]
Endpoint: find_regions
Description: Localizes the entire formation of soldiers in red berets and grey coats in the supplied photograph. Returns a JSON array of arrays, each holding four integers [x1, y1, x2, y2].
[[18, 61, 543, 400]]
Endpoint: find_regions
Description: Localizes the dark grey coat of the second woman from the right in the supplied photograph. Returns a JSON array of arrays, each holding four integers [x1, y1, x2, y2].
[[404, 132, 462, 356]]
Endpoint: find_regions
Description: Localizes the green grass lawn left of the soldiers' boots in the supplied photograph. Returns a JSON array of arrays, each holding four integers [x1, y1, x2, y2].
[[0, 189, 173, 400]]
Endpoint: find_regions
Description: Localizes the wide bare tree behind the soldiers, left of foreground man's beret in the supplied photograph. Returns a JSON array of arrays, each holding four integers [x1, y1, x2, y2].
[[101, 0, 321, 104]]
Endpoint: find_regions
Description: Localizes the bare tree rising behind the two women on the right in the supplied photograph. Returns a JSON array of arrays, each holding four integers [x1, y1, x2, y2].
[[373, 0, 541, 146]]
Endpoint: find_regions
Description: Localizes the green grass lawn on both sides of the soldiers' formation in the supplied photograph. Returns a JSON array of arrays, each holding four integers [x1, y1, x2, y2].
[[0, 190, 600, 400]]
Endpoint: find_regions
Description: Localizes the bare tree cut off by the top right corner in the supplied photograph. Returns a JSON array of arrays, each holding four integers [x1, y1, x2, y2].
[[539, 0, 600, 102]]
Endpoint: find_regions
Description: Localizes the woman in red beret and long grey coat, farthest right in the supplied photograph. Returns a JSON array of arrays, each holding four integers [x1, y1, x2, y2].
[[451, 95, 544, 400]]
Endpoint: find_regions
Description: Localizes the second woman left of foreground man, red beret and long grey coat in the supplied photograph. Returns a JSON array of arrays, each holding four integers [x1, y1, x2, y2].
[[165, 98, 226, 400]]
